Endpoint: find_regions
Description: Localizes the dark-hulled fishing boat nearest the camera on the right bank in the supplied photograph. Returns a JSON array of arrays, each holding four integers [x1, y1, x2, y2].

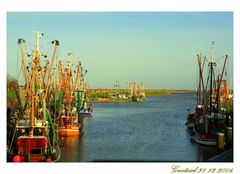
[[194, 42, 228, 146]]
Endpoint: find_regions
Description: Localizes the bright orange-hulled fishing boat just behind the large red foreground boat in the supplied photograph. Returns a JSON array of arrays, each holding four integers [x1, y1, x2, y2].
[[58, 57, 82, 136]]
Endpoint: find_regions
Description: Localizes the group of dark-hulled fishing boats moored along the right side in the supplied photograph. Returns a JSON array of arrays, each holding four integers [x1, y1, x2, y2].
[[186, 42, 233, 146]]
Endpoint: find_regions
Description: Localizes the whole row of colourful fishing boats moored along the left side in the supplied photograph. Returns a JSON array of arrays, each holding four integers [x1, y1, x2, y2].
[[7, 32, 92, 162]]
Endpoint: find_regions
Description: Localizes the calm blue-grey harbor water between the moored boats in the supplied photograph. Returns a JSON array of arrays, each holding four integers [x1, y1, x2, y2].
[[60, 94, 217, 162]]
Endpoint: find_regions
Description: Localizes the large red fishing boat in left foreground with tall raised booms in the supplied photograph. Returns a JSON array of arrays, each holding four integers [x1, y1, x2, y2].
[[7, 32, 61, 162]]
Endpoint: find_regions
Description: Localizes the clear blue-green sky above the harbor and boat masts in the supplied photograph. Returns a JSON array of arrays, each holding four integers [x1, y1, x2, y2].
[[7, 12, 233, 89]]
